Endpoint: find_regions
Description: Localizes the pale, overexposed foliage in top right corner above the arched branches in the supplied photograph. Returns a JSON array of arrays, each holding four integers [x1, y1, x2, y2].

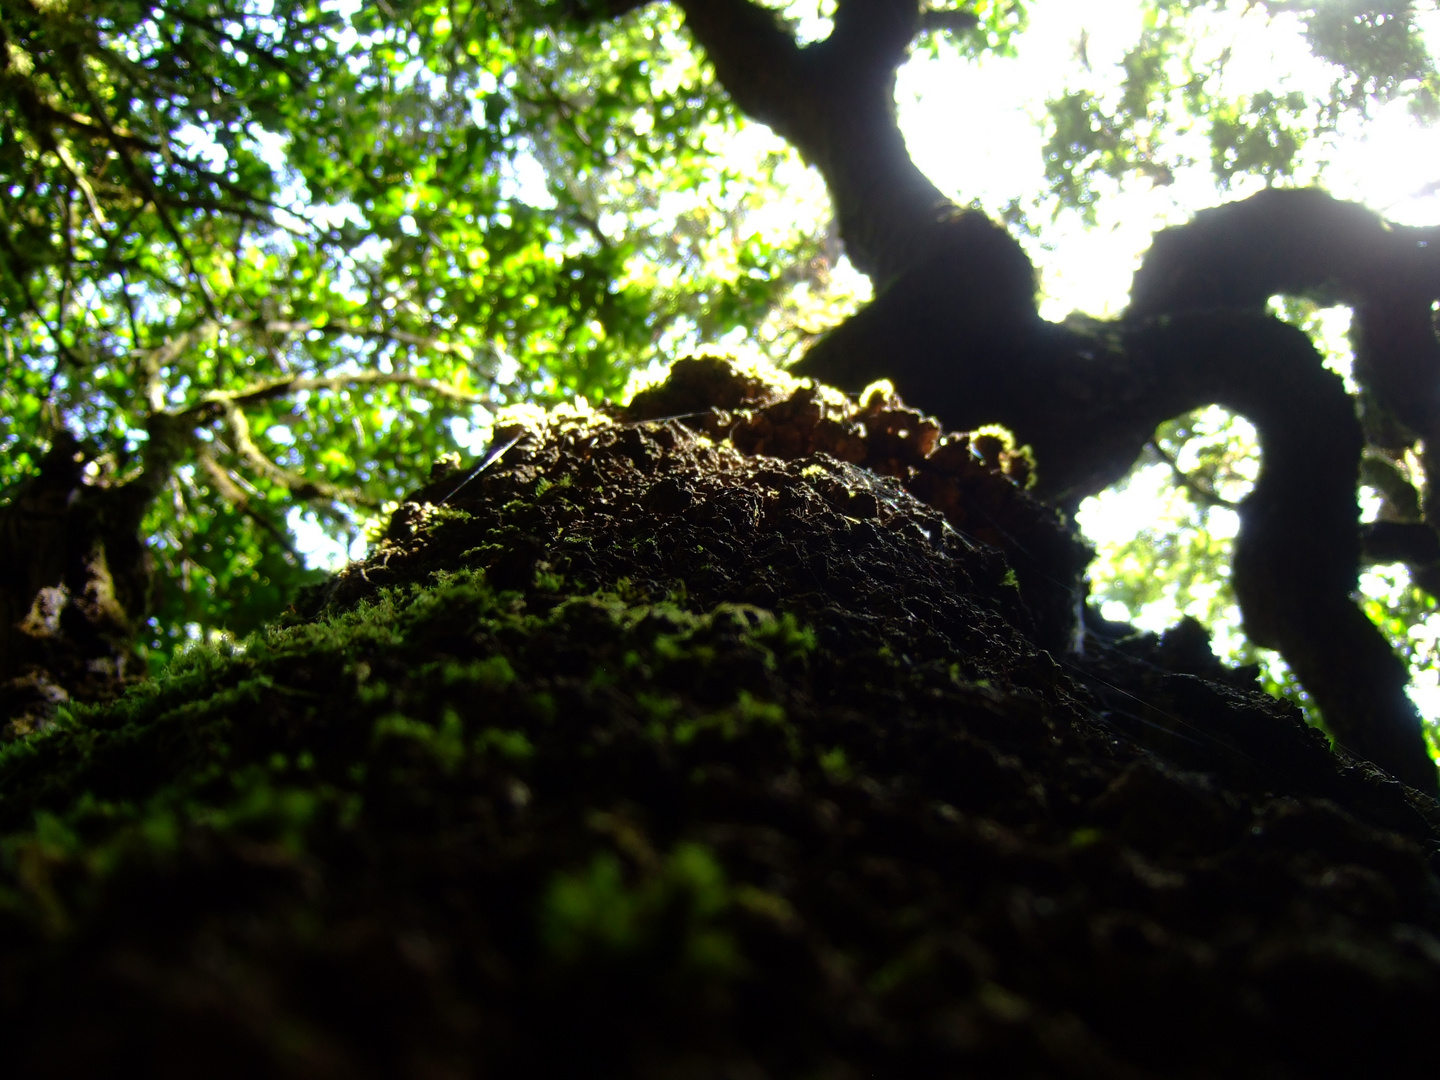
[[1044, 0, 1440, 225]]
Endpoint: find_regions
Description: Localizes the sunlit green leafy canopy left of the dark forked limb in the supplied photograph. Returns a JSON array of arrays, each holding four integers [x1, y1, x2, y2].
[[0, 0, 852, 655]]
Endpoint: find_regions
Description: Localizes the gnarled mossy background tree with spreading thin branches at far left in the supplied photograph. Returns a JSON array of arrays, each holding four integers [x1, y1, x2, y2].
[[0, 371, 449, 740]]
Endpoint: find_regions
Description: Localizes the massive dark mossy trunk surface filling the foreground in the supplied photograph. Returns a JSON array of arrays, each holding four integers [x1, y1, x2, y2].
[[0, 360, 1440, 1080]]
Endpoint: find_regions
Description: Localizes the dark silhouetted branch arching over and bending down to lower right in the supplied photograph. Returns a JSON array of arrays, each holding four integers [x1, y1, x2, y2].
[[796, 283, 1436, 791]]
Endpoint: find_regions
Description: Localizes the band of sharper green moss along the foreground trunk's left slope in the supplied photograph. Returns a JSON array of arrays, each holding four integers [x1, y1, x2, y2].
[[0, 558, 840, 907]]
